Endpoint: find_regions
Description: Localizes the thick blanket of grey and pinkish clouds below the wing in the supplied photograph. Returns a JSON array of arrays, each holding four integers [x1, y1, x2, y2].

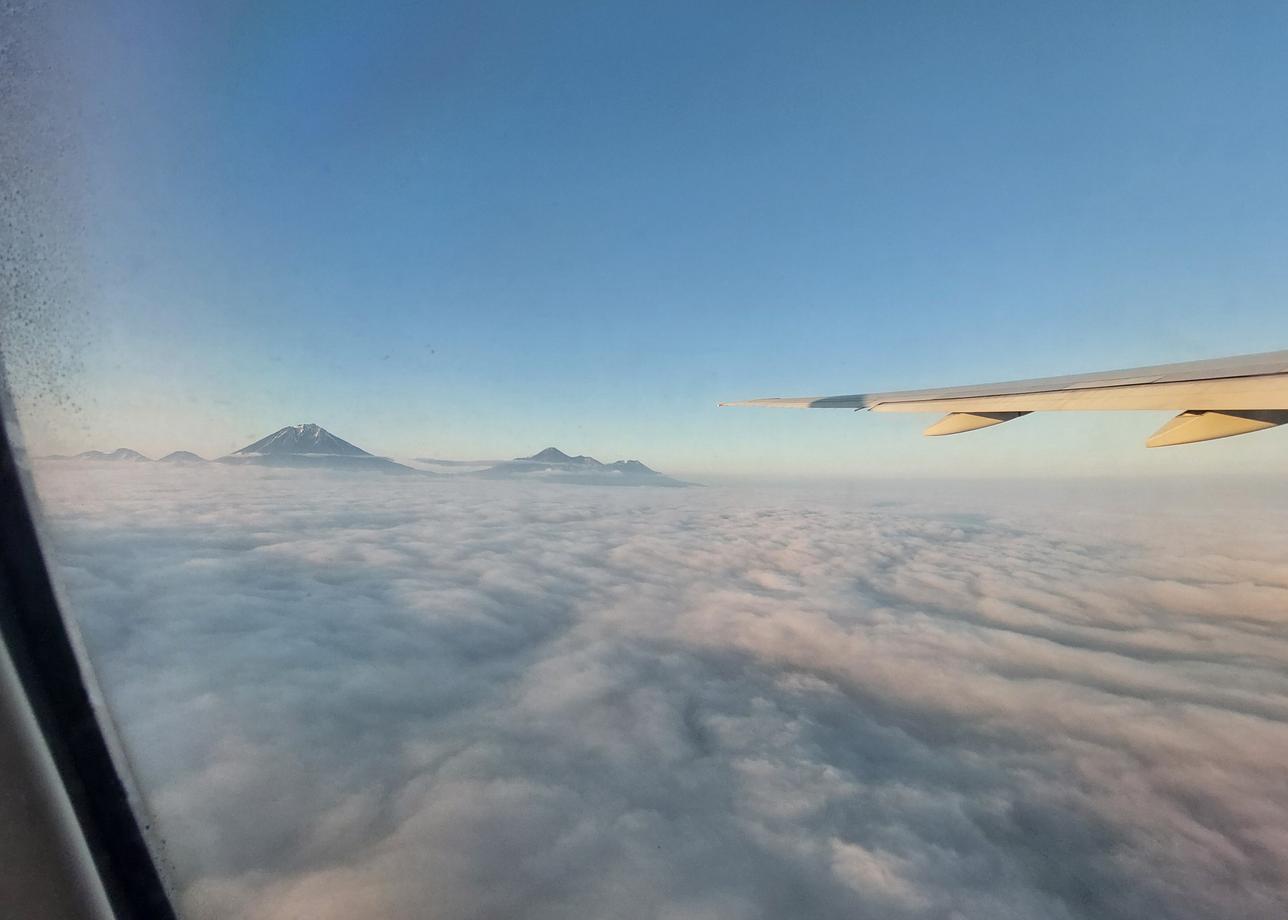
[[25, 463, 1288, 920]]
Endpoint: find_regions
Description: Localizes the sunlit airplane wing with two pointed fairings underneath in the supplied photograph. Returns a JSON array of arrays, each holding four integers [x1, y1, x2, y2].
[[720, 350, 1288, 447]]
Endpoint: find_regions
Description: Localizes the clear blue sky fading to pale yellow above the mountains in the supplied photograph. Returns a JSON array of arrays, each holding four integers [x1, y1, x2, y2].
[[10, 1, 1288, 475]]
